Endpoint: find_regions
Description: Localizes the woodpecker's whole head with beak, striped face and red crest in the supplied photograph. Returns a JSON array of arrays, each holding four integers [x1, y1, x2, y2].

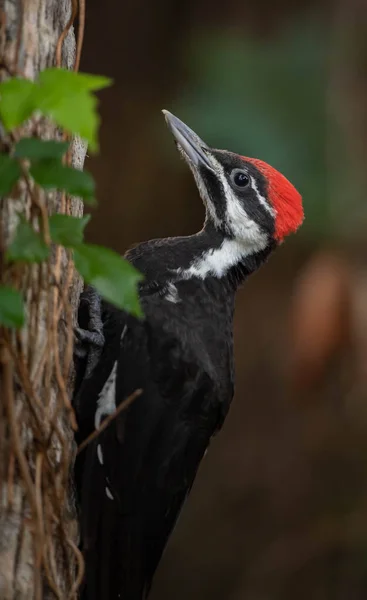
[[163, 111, 303, 248]]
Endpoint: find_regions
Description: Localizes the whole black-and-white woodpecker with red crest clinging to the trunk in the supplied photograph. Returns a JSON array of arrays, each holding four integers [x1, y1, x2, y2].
[[74, 111, 303, 600]]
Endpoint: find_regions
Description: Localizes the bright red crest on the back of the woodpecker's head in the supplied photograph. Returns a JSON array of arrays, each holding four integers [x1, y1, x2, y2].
[[242, 156, 304, 241]]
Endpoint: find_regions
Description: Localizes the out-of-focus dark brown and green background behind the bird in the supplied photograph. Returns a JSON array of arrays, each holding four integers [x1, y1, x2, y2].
[[81, 0, 367, 600]]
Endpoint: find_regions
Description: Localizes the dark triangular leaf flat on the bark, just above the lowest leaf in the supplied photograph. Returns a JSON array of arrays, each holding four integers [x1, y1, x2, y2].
[[6, 219, 49, 262]]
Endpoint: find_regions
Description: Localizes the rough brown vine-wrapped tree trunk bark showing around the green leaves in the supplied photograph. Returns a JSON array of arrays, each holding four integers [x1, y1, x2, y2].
[[0, 0, 85, 600]]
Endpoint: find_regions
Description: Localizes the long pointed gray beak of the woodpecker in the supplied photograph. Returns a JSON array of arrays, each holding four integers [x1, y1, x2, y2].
[[162, 110, 214, 171]]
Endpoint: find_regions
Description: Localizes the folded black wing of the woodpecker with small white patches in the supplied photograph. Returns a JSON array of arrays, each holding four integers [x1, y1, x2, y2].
[[77, 288, 228, 600]]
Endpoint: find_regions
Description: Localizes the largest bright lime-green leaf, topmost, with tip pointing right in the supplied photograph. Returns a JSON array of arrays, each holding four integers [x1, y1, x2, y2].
[[37, 68, 112, 151]]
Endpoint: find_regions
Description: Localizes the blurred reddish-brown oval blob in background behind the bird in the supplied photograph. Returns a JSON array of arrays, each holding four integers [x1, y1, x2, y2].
[[290, 251, 351, 390]]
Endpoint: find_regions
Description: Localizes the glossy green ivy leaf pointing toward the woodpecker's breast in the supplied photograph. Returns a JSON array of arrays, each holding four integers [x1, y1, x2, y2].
[[74, 244, 143, 317]]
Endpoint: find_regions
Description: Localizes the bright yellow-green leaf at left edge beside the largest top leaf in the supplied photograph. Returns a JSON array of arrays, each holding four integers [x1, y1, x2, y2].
[[0, 78, 37, 131]]
